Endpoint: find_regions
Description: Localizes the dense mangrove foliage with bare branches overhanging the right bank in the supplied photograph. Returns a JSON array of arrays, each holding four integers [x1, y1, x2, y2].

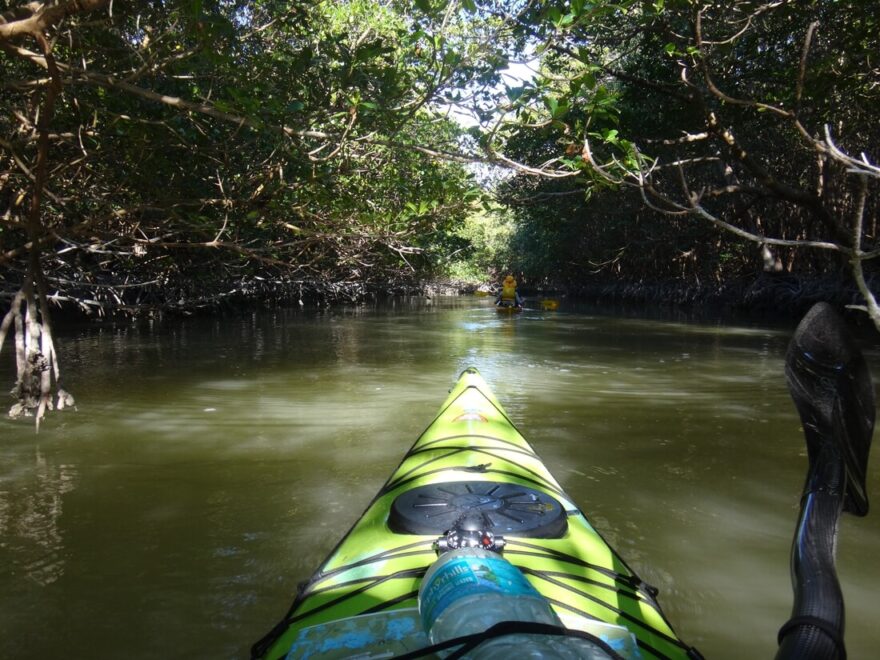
[[492, 0, 880, 302]]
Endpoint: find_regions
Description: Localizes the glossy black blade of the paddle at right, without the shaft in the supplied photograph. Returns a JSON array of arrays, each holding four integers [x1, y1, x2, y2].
[[785, 303, 875, 516]]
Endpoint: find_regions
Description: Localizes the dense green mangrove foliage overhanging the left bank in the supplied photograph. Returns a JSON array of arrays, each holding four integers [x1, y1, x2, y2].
[[0, 0, 506, 306]]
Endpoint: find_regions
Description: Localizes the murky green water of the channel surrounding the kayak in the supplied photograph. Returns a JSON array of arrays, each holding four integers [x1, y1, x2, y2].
[[0, 299, 880, 659]]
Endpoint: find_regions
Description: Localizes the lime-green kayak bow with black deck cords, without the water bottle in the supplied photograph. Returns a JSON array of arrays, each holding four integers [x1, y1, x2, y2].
[[252, 368, 700, 660]]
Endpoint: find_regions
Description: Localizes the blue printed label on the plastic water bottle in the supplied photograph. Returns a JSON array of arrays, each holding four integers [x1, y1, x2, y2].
[[419, 556, 541, 630]]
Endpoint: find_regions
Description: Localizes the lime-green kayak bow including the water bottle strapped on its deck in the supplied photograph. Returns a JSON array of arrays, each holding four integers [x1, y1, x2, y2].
[[252, 368, 701, 660]]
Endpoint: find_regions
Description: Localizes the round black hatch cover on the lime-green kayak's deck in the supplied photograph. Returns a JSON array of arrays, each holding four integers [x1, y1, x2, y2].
[[388, 481, 568, 539]]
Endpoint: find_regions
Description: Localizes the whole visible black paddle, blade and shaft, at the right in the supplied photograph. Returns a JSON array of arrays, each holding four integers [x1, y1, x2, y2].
[[776, 303, 875, 660]]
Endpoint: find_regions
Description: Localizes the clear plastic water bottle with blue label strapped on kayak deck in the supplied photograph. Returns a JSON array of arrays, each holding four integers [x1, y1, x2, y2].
[[419, 548, 624, 660]]
